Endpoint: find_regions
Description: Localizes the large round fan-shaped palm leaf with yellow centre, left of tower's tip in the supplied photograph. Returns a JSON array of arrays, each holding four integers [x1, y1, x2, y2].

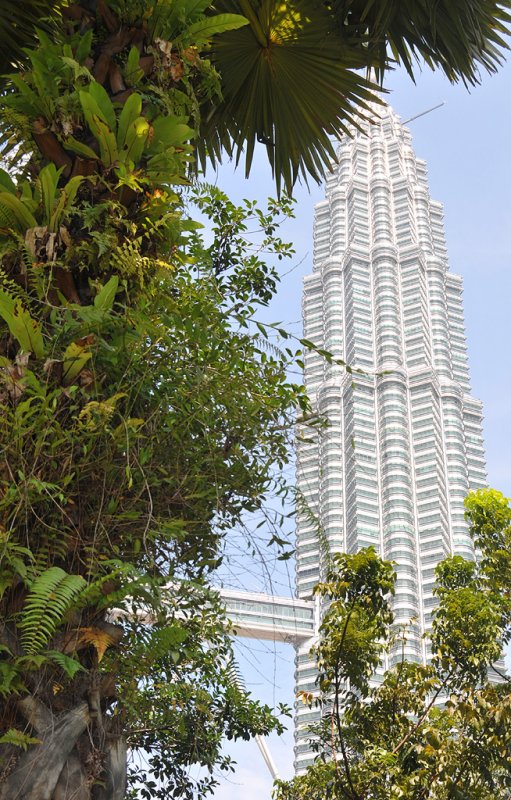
[[199, 0, 381, 190]]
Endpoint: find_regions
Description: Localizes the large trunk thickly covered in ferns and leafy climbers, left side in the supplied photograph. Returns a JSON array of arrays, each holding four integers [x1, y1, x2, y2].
[[0, 0, 307, 800]]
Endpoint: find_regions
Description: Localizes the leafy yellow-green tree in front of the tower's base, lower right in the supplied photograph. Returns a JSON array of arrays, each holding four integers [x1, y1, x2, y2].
[[275, 489, 511, 800]]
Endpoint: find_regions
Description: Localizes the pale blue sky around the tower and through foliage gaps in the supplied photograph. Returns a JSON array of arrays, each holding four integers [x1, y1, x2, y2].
[[206, 53, 511, 800]]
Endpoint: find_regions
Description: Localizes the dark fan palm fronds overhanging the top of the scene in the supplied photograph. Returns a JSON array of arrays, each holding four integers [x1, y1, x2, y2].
[[0, 0, 511, 191]]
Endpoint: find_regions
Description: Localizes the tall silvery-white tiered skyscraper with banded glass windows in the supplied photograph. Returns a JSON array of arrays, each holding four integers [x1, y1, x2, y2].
[[295, 103, 486, 770]]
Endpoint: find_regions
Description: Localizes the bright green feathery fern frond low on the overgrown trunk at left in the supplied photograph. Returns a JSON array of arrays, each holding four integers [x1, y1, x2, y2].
[[18, 567, 87, 655]]
